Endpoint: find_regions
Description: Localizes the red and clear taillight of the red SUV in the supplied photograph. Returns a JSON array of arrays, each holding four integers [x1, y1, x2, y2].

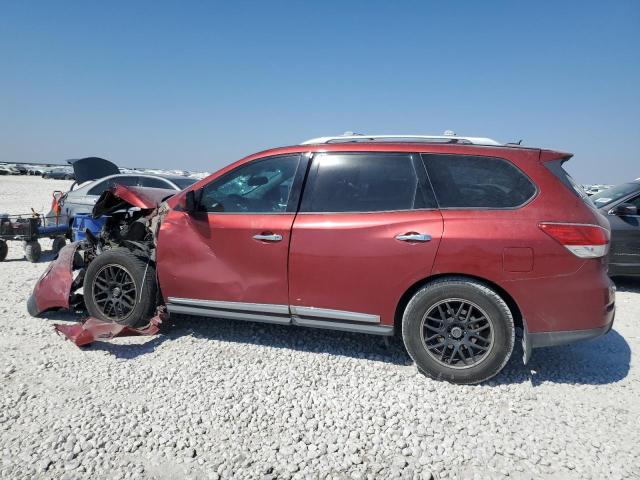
[[538, 222, 611, 258]]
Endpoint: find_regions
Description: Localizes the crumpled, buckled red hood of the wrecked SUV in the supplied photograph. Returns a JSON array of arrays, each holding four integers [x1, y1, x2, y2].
[[92, 184, 178, 218]]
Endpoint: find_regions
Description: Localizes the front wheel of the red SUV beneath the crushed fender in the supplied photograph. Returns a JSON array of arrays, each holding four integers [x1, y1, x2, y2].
[[84, 248, 158, 327]]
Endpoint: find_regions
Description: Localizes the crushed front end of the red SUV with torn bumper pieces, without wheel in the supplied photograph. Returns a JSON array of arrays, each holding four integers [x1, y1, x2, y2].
[[27, 185, 175, 346]]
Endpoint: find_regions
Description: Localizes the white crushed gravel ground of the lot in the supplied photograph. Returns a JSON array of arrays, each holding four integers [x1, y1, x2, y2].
[[0, 177, 640, 479]]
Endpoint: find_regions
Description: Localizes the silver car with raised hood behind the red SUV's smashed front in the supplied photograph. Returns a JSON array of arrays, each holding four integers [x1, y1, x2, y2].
[[58, 157, 196, 225]]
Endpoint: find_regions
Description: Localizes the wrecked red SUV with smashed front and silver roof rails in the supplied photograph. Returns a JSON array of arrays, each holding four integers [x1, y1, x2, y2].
[[29, 135, 614, 383]]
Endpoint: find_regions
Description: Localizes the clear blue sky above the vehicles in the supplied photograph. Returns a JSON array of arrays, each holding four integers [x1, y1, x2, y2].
[[0, 1, 640, 183]]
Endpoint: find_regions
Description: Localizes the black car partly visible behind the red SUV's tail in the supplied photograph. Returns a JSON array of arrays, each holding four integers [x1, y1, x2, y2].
[[589, 179, 640, 277]]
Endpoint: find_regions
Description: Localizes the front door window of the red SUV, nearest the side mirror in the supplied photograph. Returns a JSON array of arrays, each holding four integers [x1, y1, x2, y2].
[[200, 155, 299, 213]]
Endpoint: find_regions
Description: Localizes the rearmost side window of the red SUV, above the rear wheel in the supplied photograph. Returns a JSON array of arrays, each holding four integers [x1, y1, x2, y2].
[[422, 155, 536, 208]]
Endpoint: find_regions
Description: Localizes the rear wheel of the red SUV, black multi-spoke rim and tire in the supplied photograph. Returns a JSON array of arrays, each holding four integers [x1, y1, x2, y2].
[[402, 277, 515, 384]]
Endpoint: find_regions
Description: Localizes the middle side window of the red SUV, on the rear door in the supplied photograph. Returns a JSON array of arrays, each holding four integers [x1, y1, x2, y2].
[[302, 153, 435, 212]]
